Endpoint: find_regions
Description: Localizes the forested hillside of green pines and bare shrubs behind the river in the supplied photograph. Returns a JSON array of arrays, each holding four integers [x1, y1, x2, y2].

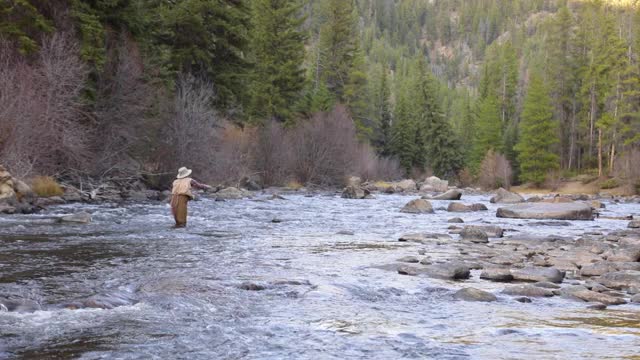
[[0, 0, 640, 193]]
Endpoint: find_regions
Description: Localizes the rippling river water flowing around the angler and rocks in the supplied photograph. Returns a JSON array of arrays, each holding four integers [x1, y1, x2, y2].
[[0, 194, 640, 359]]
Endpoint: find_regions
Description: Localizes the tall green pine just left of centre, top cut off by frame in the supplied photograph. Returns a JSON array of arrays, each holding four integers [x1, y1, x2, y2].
[[247, 0, 304, 123]]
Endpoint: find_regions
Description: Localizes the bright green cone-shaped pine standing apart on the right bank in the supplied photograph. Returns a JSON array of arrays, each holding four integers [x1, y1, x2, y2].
[[516, 74, 559, 185]]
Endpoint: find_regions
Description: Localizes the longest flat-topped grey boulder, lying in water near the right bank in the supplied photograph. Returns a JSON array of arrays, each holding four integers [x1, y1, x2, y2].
[[496, 203, 593, 220]]
